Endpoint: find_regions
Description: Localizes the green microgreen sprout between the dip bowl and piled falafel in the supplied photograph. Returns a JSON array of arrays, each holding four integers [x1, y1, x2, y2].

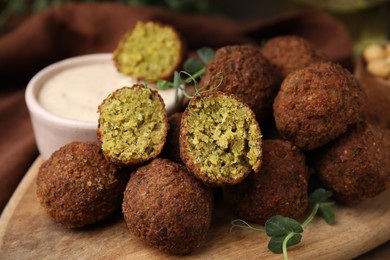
[[156, 47, 215, 102]]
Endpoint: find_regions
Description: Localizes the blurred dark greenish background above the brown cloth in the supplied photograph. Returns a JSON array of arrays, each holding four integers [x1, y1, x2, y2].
[[0, 0, 390, 53]]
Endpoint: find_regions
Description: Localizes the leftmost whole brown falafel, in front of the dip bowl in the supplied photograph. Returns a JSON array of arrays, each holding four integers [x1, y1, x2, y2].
[[36, 142, 128, 228]]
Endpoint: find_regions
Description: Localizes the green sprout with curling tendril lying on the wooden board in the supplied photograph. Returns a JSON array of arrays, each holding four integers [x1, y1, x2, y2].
[[230, 188, 335, 260]]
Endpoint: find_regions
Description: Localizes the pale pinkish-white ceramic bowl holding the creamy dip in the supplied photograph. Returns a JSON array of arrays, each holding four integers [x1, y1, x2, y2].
[[25, 53, 180, 159]]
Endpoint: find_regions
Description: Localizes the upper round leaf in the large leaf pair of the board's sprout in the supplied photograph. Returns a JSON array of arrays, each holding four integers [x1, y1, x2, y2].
[[265, 215, 303, 237]]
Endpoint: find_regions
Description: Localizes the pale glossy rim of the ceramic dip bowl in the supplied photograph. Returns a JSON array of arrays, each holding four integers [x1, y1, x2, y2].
[[25, 53, 112, 130]]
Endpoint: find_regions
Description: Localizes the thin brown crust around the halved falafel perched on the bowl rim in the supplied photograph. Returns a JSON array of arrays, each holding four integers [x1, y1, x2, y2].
[[113, 21, 187, 82]]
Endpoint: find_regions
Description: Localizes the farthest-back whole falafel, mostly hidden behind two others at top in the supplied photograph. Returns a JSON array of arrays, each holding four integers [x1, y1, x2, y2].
[[261, 35, 326, 79]]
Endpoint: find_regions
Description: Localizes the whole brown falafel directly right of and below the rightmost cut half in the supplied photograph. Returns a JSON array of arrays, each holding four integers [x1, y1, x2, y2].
[[223, 139, 309, 225]]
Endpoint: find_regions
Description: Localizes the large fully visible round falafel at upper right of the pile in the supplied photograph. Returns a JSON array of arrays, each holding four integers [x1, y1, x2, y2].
[[273, 62, 366, 150]]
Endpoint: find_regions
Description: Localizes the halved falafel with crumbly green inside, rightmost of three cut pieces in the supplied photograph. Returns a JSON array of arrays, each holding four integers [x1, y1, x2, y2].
[[179, 91, 262, 186]]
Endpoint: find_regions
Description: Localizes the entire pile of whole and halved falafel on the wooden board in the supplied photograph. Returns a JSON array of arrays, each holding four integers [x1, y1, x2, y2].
[[37, 23, 390, 254]]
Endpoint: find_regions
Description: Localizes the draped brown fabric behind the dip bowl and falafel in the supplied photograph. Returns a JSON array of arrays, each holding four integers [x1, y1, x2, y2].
[[0, 3, 351, 211]]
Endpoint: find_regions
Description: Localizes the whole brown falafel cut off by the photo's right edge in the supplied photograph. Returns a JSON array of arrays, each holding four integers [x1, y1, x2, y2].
[[315, 123, 390, 206]]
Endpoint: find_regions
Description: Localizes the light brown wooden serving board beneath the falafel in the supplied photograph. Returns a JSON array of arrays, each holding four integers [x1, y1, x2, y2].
[[0, 157, 390, 260]]
